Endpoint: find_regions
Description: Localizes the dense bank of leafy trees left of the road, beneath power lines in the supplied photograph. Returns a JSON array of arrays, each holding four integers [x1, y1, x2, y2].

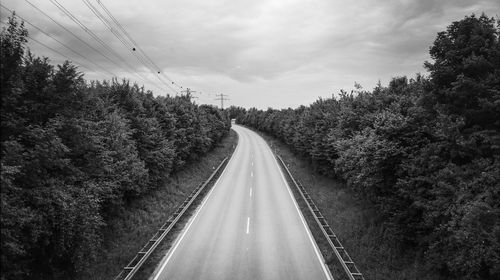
[[0, 17, 230, 279]]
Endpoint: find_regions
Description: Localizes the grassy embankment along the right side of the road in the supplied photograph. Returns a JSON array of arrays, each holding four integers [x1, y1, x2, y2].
[[260, 133, 437, 280]]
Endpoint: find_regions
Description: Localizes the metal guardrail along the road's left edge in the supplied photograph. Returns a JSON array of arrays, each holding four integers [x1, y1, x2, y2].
[[114, 157, 228, 280]]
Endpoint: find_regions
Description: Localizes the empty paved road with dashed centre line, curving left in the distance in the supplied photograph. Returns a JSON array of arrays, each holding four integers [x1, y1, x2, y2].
[[152, 125, 331, 280]]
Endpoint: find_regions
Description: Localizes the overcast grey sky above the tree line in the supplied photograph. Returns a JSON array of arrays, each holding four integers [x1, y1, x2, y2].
[[1, 0, 500, 109]]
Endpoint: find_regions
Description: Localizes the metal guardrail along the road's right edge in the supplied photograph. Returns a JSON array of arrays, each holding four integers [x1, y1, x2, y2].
[[276, 154, 365, 280]]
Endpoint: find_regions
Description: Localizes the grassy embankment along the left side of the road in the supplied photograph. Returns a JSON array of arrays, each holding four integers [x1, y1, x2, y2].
[[77, 130, 238, 280]]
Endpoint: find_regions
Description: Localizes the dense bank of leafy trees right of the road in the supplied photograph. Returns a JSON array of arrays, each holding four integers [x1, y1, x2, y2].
[[238, 15, 500, 279]]
